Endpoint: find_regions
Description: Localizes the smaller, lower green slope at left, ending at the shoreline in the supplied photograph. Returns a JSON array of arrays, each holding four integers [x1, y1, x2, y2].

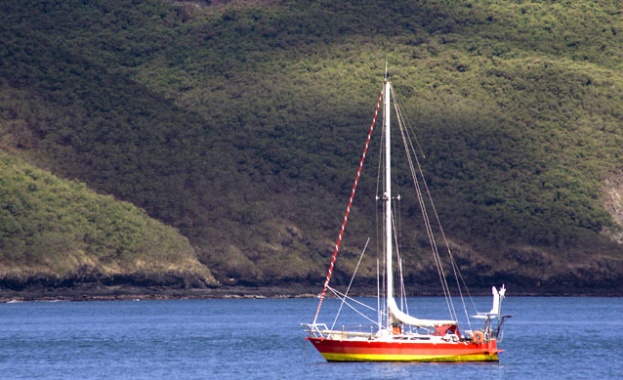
[[0, 152, 215, 289]]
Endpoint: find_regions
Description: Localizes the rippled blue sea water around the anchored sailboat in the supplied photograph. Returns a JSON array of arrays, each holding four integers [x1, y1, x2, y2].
[[0, 293, 623, 380]]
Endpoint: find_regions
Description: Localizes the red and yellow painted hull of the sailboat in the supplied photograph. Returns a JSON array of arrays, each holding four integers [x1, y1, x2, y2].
[[308, 338, 498, 362]]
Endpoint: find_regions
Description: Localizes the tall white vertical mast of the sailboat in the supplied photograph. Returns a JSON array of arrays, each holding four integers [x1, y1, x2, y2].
[[383, 78, 394, 329]]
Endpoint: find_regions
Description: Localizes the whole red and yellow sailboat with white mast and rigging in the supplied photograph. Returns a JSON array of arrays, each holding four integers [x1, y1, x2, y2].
[[303, 74, 510, 362]]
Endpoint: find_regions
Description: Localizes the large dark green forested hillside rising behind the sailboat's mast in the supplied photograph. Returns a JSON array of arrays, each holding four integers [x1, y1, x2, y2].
[[0, 0, 623, 289]]
